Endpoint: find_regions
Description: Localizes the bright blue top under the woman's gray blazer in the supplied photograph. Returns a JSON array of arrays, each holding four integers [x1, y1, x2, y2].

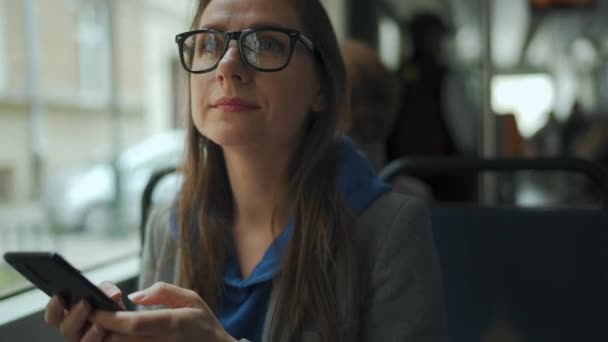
[[171, 138, 391, 342]]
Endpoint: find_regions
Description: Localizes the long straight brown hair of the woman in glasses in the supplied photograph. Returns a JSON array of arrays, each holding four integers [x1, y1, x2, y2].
[[178, 0, 359, 342]]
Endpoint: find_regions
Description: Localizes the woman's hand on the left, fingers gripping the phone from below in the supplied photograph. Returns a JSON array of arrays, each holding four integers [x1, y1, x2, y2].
[[44, 281, 125, 342]]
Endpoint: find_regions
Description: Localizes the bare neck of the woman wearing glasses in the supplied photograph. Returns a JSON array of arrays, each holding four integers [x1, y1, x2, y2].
[[223, 146, 294, 232]]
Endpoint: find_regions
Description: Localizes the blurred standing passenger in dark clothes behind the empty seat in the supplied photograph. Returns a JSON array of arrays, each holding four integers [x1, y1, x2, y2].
[[388, 13, 476, 201]]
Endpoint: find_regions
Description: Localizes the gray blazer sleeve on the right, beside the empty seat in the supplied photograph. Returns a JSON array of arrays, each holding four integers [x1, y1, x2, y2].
[[362, 198, 448, 342]]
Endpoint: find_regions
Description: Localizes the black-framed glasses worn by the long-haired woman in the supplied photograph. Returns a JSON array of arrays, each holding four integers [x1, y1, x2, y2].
[[175, 27, 315, 74]]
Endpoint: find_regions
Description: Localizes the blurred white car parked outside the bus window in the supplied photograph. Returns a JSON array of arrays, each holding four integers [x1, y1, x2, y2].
[[46, 130, 184, 232]]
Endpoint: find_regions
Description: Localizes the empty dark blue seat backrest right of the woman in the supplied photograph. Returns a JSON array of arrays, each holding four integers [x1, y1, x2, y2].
[[431, 207, 608, 342]]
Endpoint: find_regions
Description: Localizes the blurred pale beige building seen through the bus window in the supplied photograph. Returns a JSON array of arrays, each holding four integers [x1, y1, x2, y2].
[[0, 0, 191, 204]]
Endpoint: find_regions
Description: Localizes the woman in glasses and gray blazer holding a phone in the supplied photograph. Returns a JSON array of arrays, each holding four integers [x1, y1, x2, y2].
[[41, 0, 444, 342]]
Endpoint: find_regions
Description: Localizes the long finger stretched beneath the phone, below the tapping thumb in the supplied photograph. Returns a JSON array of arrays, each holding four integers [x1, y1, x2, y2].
[[91, 309, 186, 336]]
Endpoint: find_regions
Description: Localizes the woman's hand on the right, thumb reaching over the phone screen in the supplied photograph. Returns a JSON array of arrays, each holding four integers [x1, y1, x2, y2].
[[92, 282, 236, 342]]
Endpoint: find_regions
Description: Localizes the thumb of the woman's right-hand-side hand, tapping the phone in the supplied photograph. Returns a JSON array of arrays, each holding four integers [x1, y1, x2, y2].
[[129, 282, 207, 309]]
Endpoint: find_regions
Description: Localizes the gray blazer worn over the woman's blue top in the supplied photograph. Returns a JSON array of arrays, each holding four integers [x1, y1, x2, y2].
[[139, 192, 447, 342]]
